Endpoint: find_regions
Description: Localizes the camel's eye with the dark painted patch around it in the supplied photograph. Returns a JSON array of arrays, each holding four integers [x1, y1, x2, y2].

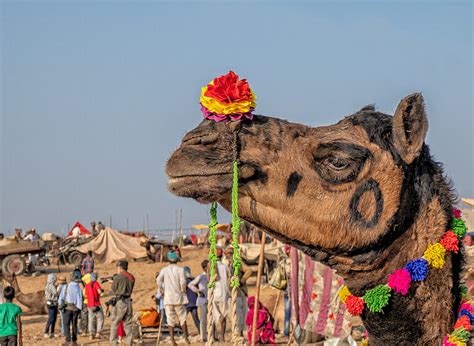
[[313, 142, 371, 184]]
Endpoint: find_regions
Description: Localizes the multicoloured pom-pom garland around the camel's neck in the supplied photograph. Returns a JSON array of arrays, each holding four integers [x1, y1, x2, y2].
[[338, 209, 474, 346]]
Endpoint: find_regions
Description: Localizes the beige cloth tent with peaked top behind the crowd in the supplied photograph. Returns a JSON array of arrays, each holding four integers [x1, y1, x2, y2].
[[77, 227, 147, 263]]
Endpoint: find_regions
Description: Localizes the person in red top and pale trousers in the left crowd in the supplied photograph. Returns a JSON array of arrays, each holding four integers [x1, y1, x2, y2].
[[85, 273, 104, 340]]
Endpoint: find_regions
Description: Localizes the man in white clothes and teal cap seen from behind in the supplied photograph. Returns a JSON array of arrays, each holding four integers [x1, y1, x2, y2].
[[156, 251, 189, 345]]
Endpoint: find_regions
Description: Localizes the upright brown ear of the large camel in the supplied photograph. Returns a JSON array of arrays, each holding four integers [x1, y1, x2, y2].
[[392, 93, 428, 164]]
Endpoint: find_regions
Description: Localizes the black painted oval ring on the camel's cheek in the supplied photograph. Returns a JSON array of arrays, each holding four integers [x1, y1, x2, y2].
[[349, 179, 384, 228]]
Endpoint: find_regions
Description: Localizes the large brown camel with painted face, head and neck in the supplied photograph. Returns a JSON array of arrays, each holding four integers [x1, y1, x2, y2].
[[166, 93, 462, 345]]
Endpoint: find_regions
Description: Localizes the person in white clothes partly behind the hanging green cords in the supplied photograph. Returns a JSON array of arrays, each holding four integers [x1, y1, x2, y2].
[[212, 249, 230, 342]]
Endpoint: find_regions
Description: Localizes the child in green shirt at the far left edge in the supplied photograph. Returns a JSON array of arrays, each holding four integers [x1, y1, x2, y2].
[[0, 286, 23, 346]]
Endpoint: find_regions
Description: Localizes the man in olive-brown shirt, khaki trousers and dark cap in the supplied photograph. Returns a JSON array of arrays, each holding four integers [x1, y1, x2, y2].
[[110, 260, 135, 345]]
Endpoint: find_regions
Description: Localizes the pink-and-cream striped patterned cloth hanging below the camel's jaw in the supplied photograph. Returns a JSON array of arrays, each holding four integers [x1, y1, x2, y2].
[[290, 248, 350, 337]]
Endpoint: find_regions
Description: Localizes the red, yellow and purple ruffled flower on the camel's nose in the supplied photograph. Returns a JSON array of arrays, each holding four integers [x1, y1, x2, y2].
[[200, 71, 257, 122]]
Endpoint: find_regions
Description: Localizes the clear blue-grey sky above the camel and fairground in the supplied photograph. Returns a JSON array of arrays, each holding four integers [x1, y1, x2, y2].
[[0, 1, 474, 233]]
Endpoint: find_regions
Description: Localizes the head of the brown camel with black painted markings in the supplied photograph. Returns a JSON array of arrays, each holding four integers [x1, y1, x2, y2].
[[166, 94, 450, 261]]
